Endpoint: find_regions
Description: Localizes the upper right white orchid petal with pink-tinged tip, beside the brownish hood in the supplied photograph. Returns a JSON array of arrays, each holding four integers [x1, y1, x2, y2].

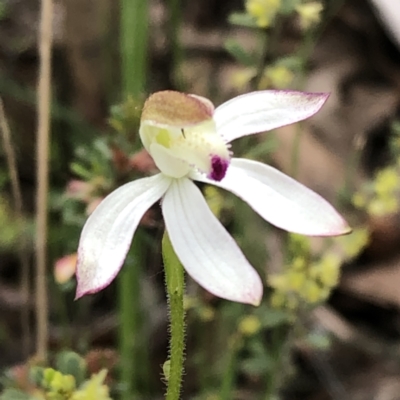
[[213, 90, 328, 143]]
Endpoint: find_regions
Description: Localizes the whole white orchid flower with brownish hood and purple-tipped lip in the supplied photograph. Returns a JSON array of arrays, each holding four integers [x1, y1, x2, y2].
[[76, 91, 349, 305]]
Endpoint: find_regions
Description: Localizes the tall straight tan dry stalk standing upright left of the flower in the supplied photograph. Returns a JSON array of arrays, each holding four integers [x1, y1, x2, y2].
[[36, 0, 53, 360]]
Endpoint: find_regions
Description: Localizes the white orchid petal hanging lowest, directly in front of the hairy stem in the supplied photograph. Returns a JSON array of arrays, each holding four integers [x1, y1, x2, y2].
[[162, 179, 263, 305]]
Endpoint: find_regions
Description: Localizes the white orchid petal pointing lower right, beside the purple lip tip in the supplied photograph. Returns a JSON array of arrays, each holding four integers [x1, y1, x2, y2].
[[192, 158, 350, 236]]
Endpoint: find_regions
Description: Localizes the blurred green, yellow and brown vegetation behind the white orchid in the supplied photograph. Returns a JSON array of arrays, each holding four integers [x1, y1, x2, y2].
[[0, 0, 400, 400]]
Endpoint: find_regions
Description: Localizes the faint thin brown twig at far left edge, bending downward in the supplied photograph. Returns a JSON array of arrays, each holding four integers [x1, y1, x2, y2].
[[0, 98, 31, 357]]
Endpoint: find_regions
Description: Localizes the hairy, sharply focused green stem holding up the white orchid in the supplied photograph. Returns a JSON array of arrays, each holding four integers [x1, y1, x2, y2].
[[162, 232, 185, 400]]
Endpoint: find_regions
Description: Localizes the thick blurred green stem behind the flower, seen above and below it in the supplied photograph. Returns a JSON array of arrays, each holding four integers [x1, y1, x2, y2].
[[119, 0, 149, 400]]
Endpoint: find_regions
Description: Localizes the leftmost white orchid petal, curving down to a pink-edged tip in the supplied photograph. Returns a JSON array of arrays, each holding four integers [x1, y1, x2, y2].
[[76, 174, 170, 298]]
